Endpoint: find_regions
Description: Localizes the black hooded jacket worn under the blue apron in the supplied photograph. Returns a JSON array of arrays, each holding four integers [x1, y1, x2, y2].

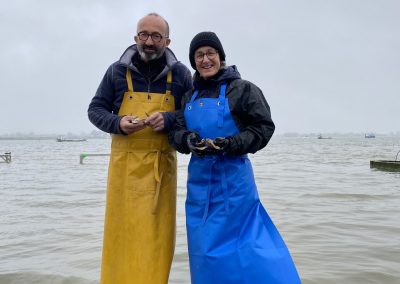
[[168, 66, 275, 155]]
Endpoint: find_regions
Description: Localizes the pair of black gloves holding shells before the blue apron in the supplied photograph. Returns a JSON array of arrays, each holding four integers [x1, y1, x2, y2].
[[187, 132, 229, 157]]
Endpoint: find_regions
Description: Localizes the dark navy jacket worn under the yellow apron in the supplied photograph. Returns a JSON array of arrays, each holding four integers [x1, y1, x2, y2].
[[88, 45, 192, 134]]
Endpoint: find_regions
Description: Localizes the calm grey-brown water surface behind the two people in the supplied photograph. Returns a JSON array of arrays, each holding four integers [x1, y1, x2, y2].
[[0, 136, 400, 284]]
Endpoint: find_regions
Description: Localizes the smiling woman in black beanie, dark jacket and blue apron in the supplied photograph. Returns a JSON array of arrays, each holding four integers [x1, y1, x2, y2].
[[169, 32, 300, 284]]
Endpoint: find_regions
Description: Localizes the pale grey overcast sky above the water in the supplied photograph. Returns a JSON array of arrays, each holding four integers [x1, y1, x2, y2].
[[0, 0, 400, 134]]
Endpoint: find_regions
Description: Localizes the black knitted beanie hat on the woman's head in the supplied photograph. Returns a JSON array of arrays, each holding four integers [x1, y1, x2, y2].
[[189, 32, 225, 70]]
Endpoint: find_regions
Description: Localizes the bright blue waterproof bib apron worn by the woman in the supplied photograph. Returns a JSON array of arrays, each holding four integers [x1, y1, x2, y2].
[[185, 85, 301, 284]]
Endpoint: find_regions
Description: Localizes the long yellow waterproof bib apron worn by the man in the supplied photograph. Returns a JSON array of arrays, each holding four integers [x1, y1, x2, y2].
[[100, 69, 176, 284]]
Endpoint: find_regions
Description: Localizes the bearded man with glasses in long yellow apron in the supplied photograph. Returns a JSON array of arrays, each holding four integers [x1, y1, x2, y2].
[[88, 13, 192, 284]]
